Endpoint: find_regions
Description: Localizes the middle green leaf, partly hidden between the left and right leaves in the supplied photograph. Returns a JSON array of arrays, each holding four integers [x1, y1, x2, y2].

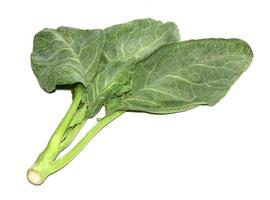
[[83, 19, 180, 116]]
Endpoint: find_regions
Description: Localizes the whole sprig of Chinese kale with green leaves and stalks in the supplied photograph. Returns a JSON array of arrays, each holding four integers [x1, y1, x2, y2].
[[27, 19, 253, 185]]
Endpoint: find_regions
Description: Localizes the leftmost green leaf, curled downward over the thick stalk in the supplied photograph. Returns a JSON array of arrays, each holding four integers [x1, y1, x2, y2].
[[31, 27, 106, 92]]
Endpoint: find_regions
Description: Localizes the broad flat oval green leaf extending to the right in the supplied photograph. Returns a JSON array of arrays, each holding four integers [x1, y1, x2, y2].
[[107, 39, 253, 114]]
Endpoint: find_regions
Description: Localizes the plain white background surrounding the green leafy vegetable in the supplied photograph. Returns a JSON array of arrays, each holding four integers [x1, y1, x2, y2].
[[0, 0, 270, 200]]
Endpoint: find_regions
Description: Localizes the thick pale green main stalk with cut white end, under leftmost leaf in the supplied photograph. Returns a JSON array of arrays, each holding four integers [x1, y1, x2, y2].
[[27, 84, 84, 185]]
